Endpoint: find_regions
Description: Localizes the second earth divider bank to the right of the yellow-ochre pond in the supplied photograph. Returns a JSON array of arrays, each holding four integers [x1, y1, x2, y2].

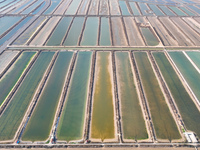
[[129, 51, 156, 142]]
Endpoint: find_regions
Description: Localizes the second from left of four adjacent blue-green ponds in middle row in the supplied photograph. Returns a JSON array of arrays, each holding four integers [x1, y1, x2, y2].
[[63, 17, 85, 46]]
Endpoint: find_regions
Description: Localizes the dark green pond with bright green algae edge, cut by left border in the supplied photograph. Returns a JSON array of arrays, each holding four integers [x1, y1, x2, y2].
[[0, 52, 35, 106]]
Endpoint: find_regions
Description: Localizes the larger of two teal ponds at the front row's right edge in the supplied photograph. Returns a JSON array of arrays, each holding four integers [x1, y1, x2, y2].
[[169, 52, 200, 101]]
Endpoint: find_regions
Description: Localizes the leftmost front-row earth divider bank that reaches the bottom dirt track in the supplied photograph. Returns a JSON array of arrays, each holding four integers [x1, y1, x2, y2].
[[15, 51, 59, 140]]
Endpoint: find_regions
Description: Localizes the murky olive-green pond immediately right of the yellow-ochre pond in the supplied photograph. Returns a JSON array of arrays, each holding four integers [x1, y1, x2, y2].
[[116, 52, 148, 140]]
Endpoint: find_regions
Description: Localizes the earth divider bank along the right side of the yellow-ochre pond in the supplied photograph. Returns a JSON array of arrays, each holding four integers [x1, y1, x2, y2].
[[111, 51, 123, 143]]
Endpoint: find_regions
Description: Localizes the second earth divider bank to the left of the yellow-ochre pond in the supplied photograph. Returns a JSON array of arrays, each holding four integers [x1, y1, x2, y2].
[[50, 52, 78, 141]]
